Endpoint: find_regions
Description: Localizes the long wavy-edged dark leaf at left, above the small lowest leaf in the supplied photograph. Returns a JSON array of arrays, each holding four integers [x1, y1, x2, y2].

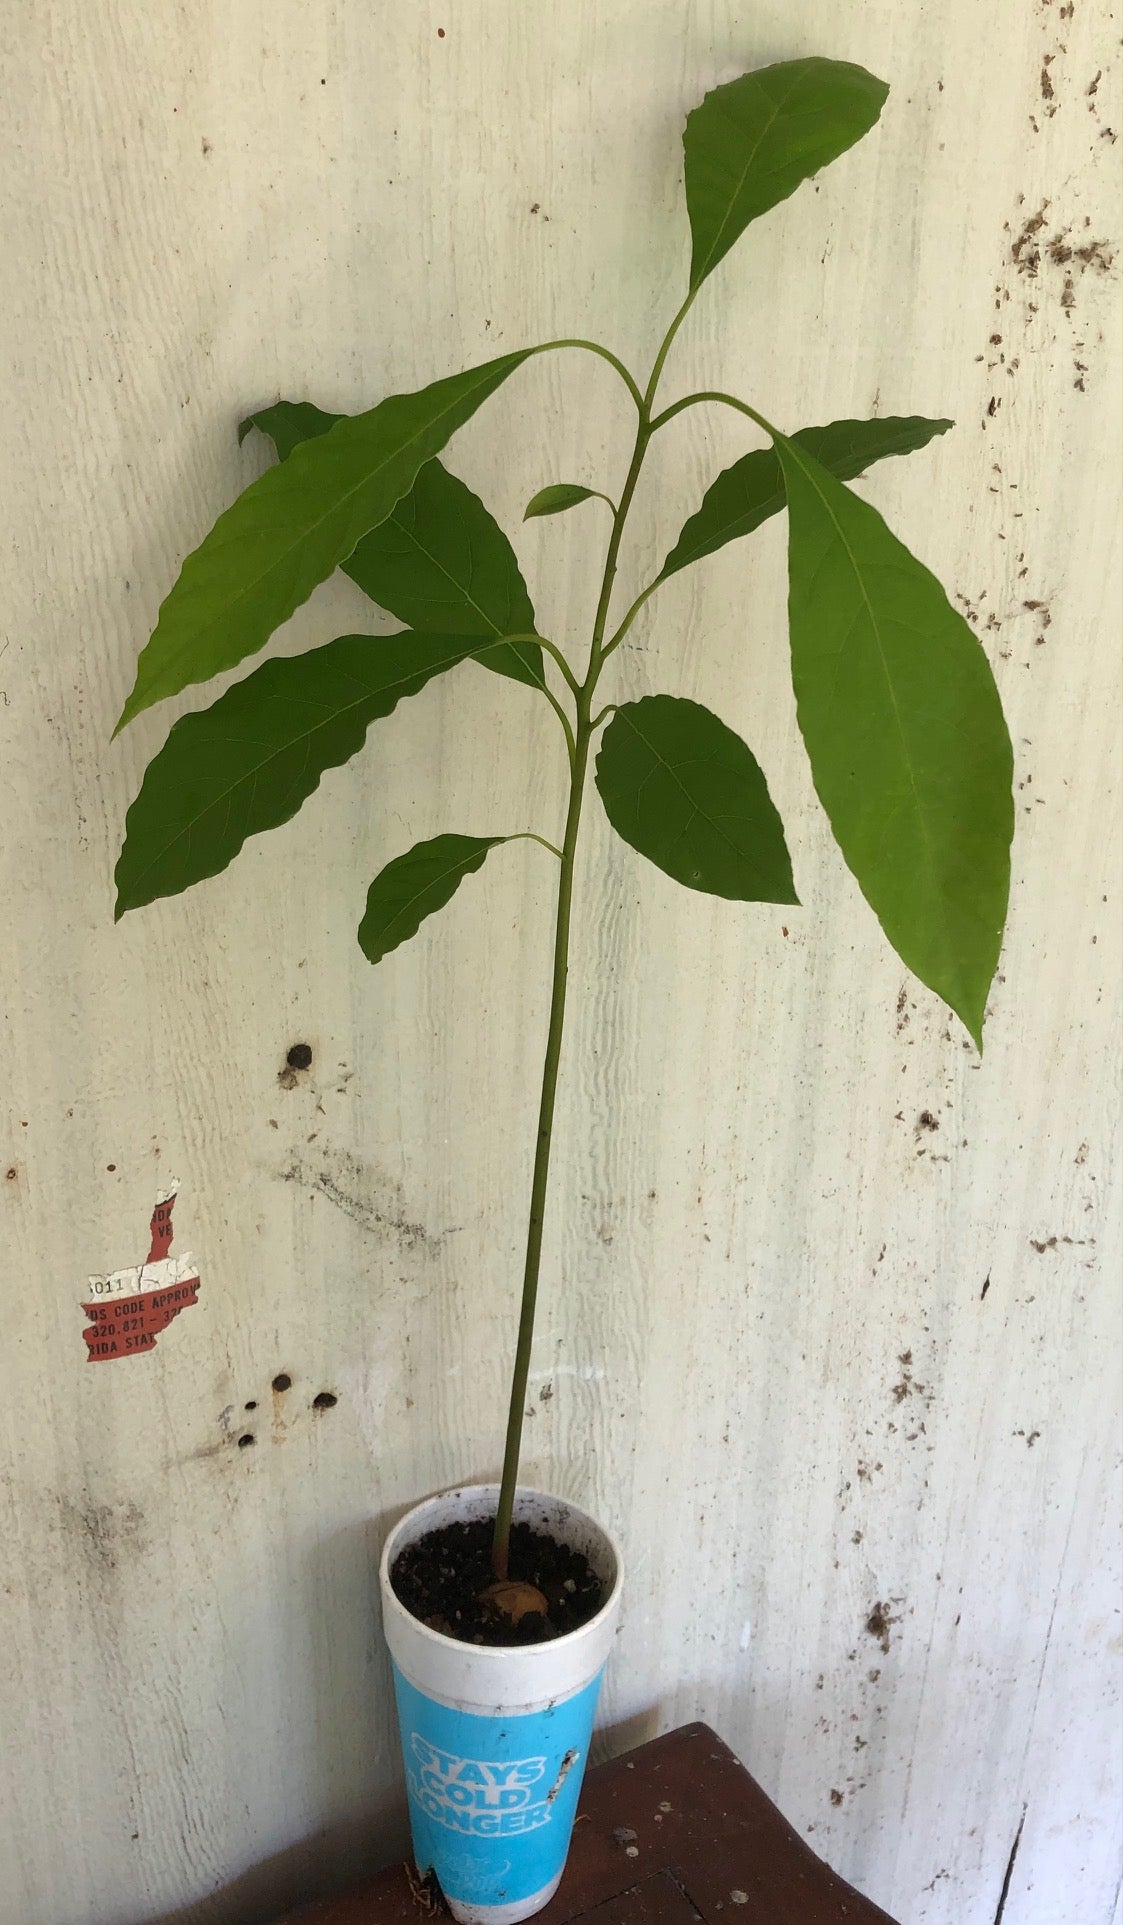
[[116, 633, 496, 918]]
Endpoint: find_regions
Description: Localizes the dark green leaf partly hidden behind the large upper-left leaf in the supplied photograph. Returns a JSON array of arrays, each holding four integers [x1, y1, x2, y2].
[[239, 400, 545, 687]]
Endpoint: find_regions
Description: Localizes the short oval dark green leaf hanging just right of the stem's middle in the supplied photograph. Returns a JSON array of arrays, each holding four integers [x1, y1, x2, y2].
[[597, 695, 797, 903]]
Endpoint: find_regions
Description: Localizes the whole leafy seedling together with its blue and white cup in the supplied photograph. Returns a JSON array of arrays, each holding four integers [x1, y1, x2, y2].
[[116, 60, 1013, 1921]]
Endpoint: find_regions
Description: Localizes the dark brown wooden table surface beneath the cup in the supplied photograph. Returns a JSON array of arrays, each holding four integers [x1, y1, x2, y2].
[[277, 1725, 894, 1925]]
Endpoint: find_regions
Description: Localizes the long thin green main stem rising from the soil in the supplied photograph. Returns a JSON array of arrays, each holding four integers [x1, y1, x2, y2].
[[491, 293, 693, 1579]]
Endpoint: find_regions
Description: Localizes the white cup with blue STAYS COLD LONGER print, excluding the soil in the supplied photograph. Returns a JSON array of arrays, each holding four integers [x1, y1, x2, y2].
[[379, 1484, 622, 1925]]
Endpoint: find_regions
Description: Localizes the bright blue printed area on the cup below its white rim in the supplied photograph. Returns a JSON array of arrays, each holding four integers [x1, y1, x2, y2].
[[393, 1665, 601, 1906]]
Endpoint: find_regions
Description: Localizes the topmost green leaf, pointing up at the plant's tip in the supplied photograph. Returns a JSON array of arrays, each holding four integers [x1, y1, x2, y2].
[[682, 60, 888, 289]]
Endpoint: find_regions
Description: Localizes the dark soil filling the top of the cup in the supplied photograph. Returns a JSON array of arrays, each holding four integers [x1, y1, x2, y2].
[[389, 1517, 603, 1644]]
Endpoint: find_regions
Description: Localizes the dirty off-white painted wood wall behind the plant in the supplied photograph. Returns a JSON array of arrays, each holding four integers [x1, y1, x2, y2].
[[0, 0, 1123, 1925]]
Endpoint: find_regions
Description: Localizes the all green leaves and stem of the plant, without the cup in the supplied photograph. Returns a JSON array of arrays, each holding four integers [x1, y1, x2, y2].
[[118, 60, 1013, 1577]]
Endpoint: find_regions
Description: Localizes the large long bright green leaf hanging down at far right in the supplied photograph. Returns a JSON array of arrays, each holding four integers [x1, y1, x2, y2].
[[776, 437, 1013, 1047]]
